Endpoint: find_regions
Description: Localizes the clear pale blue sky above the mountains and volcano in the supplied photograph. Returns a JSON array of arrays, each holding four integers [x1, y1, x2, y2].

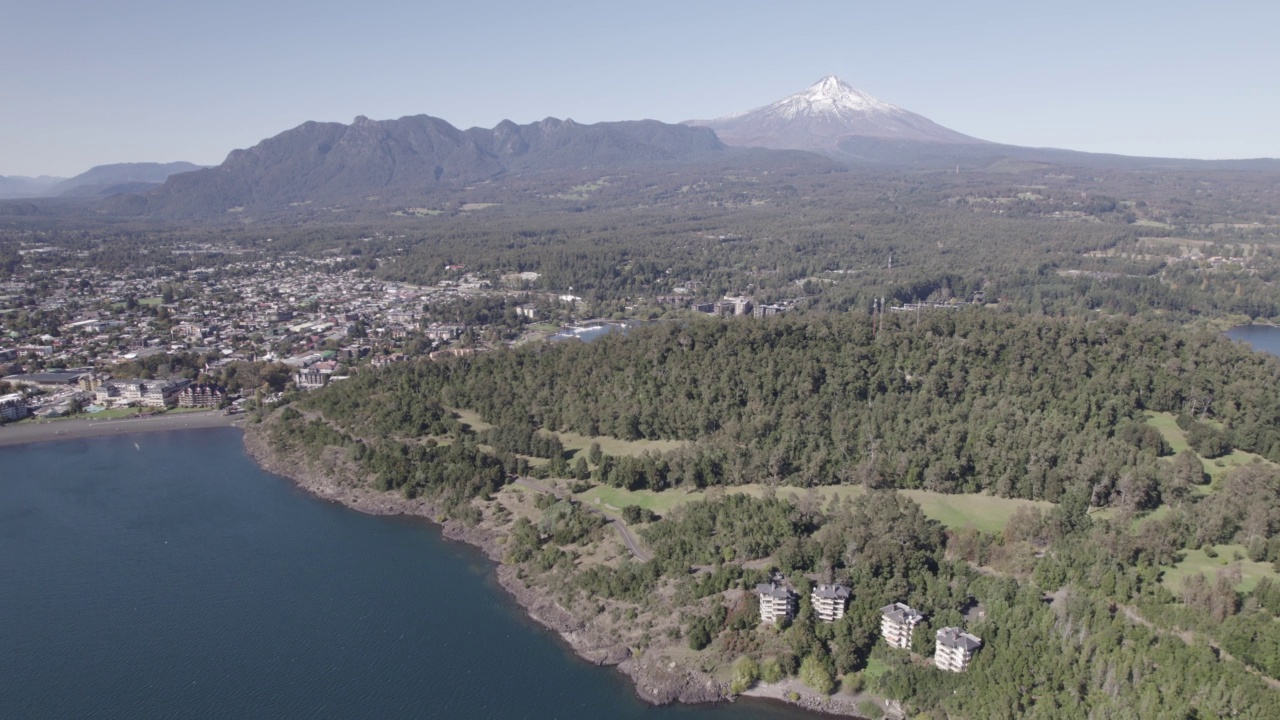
[[0, 0, 1280, 176]]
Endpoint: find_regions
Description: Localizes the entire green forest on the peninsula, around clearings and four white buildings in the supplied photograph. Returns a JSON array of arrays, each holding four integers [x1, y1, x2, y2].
[[254, 306, 1280, 717]]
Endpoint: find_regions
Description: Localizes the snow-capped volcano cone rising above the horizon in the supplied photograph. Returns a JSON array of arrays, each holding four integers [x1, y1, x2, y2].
[[687, 76, 983, 154]]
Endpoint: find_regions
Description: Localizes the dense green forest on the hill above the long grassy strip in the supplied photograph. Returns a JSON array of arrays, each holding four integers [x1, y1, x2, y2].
[[293, 307, 1280, 510]]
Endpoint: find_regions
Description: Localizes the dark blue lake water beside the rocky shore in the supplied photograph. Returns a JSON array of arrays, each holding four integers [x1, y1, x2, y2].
[[0, 429, 801, 720]]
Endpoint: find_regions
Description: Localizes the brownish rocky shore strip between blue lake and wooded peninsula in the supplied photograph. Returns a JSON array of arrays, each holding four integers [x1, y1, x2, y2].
[[244, 425, 747, 705]]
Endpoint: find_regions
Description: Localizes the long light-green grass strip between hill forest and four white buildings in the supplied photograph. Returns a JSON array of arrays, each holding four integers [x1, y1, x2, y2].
[[577, 484, 1053, 533]]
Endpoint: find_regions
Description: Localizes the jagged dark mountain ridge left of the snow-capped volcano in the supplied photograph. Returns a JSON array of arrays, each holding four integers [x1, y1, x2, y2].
[[133, 115, 724, 217]]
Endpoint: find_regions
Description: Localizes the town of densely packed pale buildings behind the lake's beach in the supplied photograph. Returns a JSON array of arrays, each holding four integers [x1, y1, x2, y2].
[[0, 243, 803, 423]]
